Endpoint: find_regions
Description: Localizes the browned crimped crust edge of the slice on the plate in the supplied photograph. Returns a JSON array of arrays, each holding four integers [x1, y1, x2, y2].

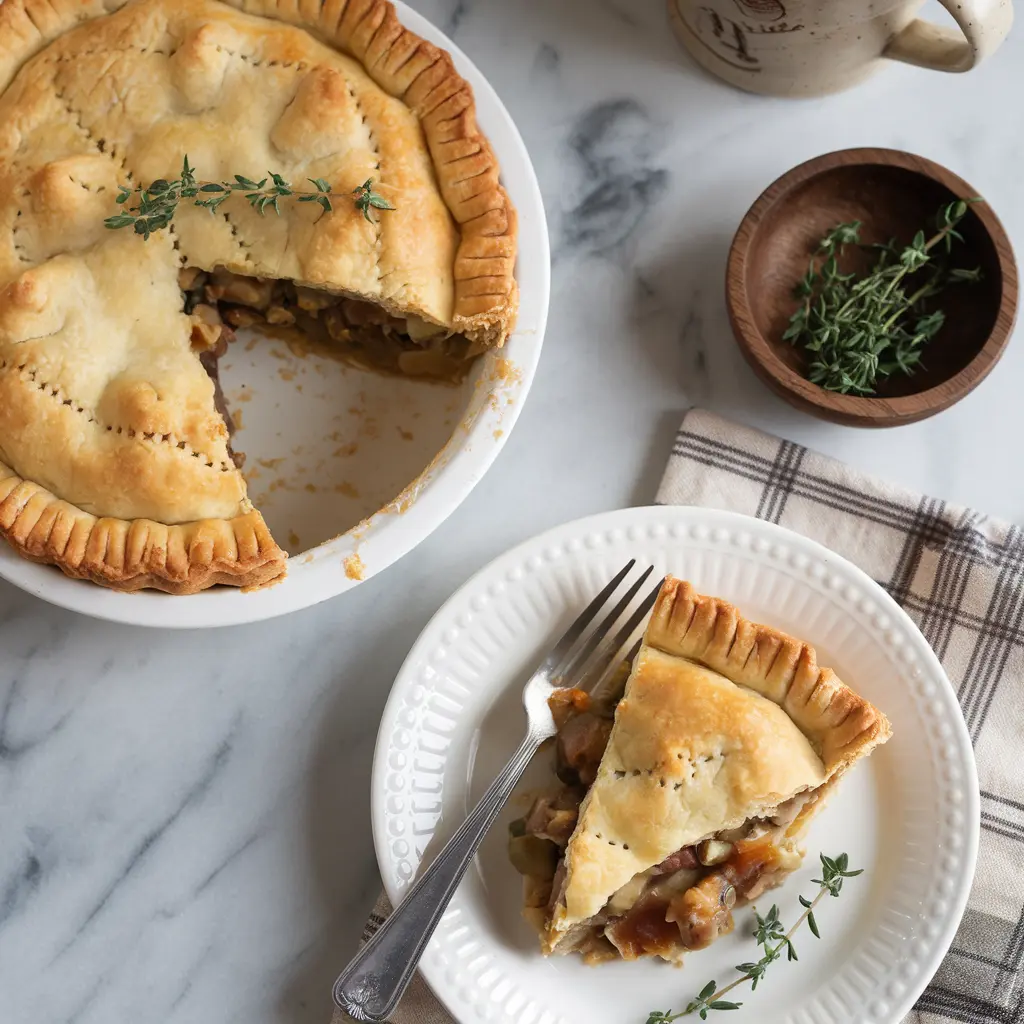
[[645, 577, 892, 778]]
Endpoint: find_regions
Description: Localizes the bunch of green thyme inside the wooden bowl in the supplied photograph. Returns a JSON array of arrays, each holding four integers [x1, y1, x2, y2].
[[782, 199, 981, 395]]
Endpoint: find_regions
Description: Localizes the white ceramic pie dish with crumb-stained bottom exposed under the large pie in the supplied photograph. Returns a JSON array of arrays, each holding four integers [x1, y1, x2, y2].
[[0, 0, 550, 628]]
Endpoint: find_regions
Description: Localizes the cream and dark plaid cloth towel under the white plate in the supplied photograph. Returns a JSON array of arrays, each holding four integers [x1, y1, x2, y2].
[[332, 410, 1024, 1024]]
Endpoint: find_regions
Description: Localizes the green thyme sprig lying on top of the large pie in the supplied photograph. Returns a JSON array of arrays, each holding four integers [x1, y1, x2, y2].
[[103, 155, 394, 239]]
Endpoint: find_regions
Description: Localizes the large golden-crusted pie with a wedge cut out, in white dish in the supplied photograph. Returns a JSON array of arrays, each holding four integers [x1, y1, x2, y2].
[[0, 0, 517, 594]]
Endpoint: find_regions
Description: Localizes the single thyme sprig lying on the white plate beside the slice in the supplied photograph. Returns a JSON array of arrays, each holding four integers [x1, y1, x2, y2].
[[647, 853, 863, 1024]]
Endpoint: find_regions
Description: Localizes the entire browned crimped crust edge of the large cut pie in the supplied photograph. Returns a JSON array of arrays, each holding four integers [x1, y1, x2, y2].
[[0, 0, 518, 594]]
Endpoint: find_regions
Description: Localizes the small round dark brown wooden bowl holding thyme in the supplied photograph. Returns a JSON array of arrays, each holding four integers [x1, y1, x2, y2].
[[726, 148, 1017, 427]]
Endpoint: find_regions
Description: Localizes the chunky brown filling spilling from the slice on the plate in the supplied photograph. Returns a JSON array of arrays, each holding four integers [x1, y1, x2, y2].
[[509, 690, 822, 963]]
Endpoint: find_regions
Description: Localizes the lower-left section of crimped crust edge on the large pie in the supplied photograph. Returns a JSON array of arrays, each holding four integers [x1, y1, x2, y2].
[[0, 463, 288, 594]]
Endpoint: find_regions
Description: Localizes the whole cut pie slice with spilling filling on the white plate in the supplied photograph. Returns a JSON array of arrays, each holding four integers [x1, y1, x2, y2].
[[509, 577, 891, 962]]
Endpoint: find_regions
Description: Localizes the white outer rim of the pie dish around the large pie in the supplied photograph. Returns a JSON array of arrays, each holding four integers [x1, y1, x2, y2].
[[0, 0, 551, 629]]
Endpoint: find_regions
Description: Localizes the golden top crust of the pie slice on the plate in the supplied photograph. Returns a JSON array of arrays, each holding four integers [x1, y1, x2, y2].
[[545, 577, 891, 951]]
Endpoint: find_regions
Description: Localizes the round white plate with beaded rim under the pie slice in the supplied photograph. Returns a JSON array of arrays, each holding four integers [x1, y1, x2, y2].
[[372, 506, 980, 1024]]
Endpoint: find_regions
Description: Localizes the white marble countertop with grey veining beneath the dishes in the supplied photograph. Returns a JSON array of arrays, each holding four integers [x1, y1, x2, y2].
[[0, 0, 1024, 1024]]
